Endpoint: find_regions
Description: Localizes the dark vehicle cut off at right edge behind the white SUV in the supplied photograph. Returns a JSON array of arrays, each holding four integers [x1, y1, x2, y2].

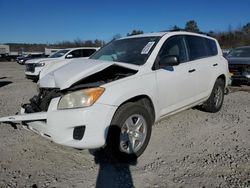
[[227, 46, 250, 84]]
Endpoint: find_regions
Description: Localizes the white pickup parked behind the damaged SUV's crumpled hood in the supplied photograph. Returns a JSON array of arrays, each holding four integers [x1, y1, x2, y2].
[[25, 47, 99, 80]]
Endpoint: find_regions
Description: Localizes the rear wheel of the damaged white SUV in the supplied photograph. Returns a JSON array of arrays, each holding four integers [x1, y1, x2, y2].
[[202, 78, 225, 113]]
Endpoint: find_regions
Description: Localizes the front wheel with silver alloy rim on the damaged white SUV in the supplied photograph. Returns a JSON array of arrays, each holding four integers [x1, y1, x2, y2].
[[104, 103, 153, 163]]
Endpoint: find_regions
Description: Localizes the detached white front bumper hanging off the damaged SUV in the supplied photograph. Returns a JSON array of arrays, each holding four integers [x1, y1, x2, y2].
[[0, 97, 117, 149]]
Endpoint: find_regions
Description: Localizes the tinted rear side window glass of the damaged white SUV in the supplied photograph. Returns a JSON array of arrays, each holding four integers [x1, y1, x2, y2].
[[186, 36, 218, 61]]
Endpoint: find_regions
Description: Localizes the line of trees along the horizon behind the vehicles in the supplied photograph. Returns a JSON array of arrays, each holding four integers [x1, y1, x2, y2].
[[4, 20, 250, 52]]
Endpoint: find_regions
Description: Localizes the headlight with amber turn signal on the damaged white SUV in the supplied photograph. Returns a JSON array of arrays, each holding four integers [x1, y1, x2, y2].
[[57, 87, 105, 110]]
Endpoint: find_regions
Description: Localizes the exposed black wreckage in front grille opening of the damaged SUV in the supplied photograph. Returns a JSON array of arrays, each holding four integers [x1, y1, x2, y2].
[[22, 88, 62, 113]]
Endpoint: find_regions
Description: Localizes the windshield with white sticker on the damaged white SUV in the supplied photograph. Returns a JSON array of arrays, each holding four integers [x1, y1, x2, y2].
[[90, 37, 160, 65]]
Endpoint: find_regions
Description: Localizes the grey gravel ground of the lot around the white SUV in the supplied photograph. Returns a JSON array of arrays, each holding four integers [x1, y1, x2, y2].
[[0, 62, 250, 188]]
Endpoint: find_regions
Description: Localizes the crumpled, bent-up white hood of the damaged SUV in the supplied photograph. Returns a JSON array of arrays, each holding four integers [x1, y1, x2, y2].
[[39, 59, 115, 90]]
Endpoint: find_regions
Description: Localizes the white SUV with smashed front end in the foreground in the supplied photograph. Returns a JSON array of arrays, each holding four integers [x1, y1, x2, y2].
[[0, 31, 229, 161]]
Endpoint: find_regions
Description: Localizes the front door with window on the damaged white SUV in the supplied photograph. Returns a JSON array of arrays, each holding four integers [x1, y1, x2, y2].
[[156, 36, 197, 116]]
